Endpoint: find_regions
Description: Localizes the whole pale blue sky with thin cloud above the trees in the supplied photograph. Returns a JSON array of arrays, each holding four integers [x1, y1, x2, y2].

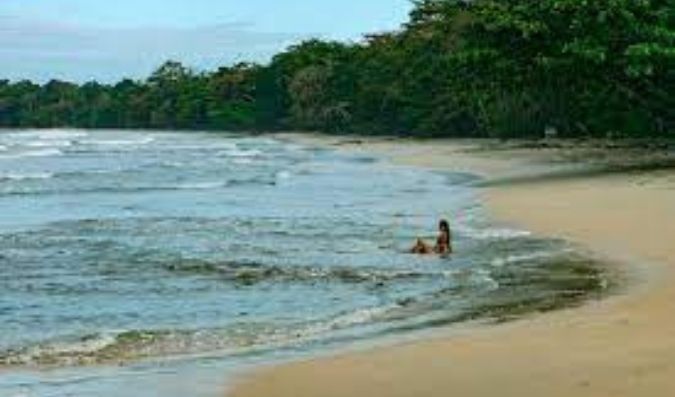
[[0, 0, 411, 82]]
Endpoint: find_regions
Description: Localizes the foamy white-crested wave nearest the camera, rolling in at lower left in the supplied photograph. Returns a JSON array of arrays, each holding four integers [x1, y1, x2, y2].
[[0, 302, 434, 366]]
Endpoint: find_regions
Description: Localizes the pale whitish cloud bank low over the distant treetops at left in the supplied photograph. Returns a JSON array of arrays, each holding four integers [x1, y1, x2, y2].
[[0, 16, 303, 82]]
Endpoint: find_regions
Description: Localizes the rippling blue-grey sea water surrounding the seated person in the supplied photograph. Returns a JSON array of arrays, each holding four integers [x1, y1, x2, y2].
[[0, 130, 607, 396]]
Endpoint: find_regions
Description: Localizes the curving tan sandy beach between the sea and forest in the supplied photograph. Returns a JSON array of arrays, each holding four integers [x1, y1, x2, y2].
[[228, 136, 675, 397]]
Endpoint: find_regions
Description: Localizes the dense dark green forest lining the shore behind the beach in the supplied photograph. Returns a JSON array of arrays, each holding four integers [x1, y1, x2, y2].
[[0, 0, 675, 138]]
